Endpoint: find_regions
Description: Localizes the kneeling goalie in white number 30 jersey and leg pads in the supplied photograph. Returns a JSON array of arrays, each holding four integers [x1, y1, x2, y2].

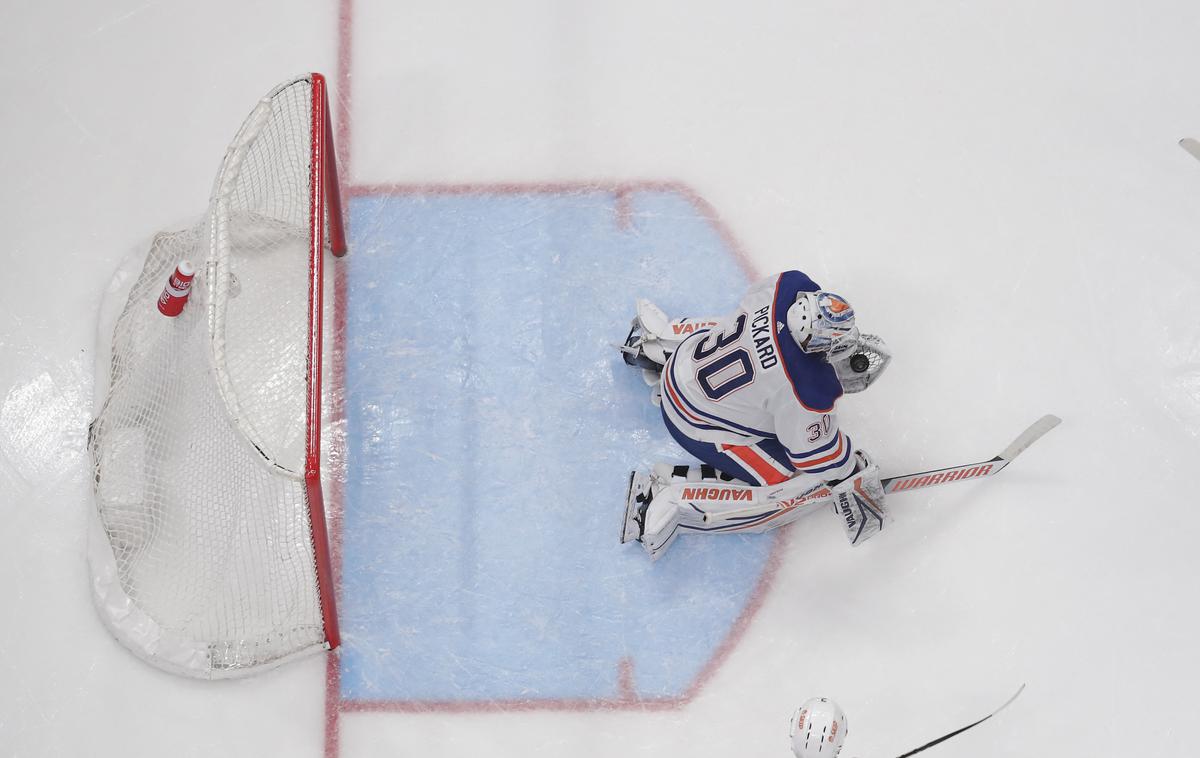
[[620, 271, 892, 558]]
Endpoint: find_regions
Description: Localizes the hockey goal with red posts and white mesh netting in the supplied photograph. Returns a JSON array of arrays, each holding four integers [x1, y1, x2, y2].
[[89, 74, 346, 679]]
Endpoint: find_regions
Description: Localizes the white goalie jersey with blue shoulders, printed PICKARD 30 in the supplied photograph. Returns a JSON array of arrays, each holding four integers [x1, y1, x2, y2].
[[662, 271, 854, 481]]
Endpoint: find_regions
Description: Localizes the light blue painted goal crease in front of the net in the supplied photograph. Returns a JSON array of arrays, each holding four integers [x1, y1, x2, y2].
[[341, 191, 772, 702]]
